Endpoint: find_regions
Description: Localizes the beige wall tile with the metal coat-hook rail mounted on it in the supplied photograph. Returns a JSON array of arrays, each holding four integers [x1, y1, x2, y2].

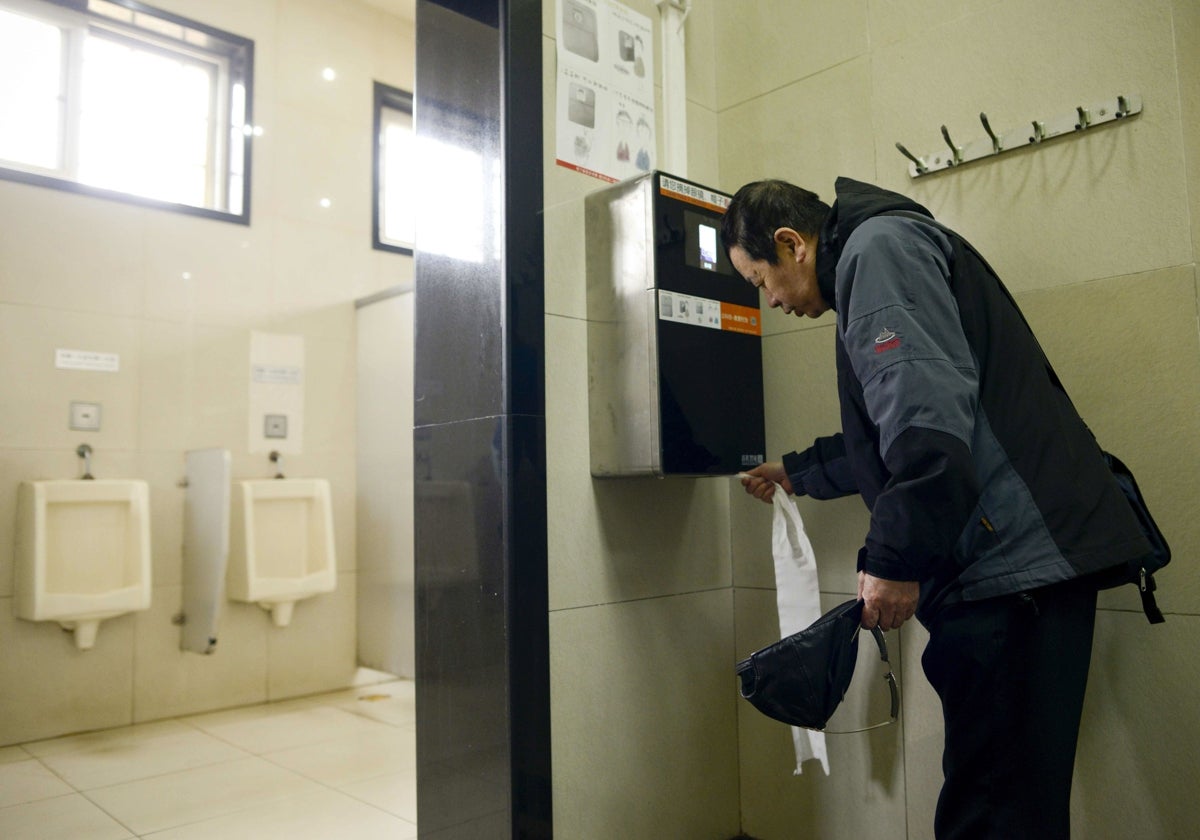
[[871, 0, 1190, 290]]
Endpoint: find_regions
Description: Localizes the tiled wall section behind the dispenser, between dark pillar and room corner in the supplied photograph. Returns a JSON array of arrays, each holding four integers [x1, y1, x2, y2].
[[542, 0, 740, 840]]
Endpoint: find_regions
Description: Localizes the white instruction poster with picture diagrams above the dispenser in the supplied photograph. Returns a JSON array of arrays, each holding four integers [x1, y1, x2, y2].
[[556, 0, 654, 182]]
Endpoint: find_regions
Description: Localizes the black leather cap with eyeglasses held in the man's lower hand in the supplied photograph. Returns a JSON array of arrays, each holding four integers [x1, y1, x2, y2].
[[736, 600, 900, 734]]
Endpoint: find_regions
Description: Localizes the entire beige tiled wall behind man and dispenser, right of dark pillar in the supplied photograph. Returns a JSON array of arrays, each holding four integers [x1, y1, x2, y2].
[[544, 0, 1200, 839]]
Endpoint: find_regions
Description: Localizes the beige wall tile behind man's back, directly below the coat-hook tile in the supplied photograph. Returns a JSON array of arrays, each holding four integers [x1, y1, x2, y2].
[[1020, 266, 1200, 614]]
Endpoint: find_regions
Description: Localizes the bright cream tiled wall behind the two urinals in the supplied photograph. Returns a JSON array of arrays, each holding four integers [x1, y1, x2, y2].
[[0, 0, 413, 744]]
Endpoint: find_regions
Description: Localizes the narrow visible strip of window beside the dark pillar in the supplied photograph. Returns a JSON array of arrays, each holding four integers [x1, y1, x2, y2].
[[372, 82, 416, 254]]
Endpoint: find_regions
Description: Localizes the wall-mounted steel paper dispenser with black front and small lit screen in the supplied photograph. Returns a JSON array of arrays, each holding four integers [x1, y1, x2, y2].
[[584, 172, 766, 476]]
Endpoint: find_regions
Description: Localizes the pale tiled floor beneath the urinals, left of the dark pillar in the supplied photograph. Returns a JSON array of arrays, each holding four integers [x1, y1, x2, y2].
[[0, 680, 416, 840]]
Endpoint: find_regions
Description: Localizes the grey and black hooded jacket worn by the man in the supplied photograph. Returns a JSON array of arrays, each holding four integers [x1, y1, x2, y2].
[[784, 178, 1150, 620]]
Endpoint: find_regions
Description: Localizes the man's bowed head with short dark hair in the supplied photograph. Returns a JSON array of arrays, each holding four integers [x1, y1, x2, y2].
[[721, 180, 829, 318]]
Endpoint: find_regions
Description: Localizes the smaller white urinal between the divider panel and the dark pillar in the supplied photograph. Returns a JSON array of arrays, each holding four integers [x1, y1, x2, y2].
[[226, 479, 337, 628]]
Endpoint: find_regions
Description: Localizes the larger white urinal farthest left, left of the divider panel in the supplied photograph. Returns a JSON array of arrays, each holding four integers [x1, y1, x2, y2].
[[14, 480, 150, 650]]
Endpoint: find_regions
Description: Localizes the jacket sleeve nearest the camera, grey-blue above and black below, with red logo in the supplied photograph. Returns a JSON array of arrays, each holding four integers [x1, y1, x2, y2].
[[838, 217, 979, 581]]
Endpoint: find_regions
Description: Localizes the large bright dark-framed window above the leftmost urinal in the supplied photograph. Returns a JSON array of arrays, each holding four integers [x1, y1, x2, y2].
[[0, 0, 254, 224]]
